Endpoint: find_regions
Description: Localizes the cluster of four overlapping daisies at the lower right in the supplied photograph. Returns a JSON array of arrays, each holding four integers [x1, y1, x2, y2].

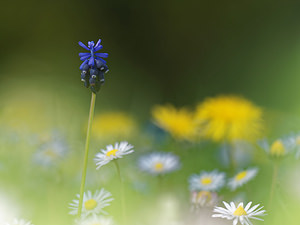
[[189, 168, 266, 225]]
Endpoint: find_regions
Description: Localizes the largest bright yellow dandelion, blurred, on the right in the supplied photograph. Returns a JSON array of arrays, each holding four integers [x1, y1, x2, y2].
[[196, 96, 263, 142]]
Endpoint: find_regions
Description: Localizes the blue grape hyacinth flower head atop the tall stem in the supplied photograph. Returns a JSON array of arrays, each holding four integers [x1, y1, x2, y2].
[[78, 39, 109, 93]]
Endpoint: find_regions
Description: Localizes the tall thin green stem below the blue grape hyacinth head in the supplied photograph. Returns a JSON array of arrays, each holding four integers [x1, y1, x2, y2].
[[78, 92, 96, 218]]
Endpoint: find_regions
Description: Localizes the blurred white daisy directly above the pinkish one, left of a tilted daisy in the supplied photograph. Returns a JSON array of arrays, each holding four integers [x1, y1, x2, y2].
[[189, 170, 225, 191]]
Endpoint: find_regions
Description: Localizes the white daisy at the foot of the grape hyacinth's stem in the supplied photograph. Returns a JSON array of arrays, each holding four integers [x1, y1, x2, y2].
[[69, 188, 113, 217]]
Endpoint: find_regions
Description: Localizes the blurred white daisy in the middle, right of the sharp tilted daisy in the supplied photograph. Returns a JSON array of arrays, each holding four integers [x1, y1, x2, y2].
[[138, 152, 180, 175]]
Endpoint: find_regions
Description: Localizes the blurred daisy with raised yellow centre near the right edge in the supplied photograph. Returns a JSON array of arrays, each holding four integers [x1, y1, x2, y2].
[[258, 138, 294, 158]]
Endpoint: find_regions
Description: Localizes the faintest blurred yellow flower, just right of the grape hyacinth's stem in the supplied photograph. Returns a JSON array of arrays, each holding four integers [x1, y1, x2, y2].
[[92, 112, 137, 139]]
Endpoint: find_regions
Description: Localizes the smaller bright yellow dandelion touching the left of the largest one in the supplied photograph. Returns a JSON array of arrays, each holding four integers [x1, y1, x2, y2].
[[152, 105, 196, 140]]
